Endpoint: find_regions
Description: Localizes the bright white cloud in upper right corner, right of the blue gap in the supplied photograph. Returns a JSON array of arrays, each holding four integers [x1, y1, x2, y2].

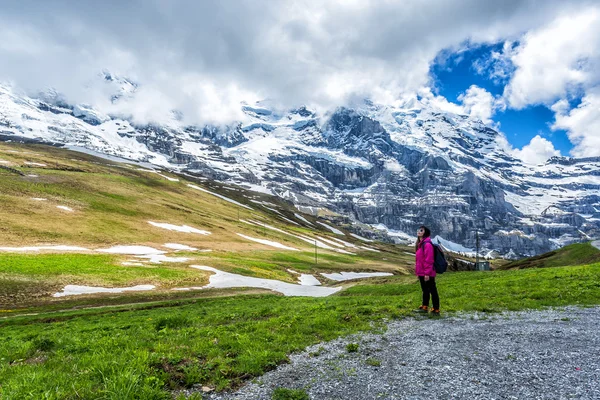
[[504, 5, 600, 108]]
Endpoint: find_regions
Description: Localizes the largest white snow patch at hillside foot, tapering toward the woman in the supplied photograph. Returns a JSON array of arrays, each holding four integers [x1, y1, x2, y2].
[[192, 265, 342, 297]]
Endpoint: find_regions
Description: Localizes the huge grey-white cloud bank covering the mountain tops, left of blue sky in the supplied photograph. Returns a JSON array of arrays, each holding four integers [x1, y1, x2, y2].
[[0, 0, 584, 122]]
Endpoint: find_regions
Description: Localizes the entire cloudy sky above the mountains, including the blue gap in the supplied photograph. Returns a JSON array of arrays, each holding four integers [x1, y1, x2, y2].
[[0, 0, 600, 162]]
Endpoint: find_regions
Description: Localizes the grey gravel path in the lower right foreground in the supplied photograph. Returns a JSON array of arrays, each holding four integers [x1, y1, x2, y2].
[[205, 307, 600, 400]]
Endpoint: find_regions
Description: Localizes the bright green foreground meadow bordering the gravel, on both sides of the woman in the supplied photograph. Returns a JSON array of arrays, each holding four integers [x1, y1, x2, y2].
[[0, 263, 600, 399]]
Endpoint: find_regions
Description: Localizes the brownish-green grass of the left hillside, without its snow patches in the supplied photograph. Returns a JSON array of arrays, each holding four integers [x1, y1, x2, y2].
[[0, 143, 412, 308]]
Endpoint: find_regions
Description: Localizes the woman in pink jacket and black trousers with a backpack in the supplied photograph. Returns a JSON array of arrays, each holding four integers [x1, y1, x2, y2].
[[415, 226, 440, 315]]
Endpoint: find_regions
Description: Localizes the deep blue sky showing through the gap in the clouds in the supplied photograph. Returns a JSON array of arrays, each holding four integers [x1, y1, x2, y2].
[[431, 44, 579, 155]]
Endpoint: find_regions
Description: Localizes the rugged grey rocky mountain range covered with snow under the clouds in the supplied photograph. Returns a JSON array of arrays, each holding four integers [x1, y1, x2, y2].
[[0, 81, 600, 255]]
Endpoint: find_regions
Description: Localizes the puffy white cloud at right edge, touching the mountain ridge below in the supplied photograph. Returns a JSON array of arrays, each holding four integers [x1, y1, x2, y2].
[[552, 86, 600, 157]]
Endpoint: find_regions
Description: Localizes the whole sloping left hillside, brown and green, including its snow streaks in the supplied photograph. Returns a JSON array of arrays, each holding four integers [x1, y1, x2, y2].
[[0, 143, 412, 308]]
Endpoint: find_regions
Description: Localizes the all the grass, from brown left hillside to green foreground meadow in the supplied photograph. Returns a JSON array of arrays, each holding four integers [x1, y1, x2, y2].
[[0, 144, 600, 399]]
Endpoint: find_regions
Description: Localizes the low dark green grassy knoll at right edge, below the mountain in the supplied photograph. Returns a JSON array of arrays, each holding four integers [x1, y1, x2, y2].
[[497, 242, 600, 269]]
